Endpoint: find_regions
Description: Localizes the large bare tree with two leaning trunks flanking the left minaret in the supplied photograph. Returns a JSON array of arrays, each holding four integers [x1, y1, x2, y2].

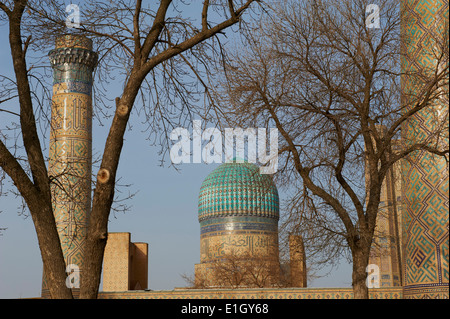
[[0, 0, 256, 298]]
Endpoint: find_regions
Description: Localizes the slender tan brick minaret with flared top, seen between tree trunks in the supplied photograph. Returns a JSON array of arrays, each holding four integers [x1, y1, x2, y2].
[[42, 34, 97, 297]]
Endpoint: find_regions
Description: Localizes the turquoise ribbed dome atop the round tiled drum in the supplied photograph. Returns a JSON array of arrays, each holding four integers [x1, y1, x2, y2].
[[198, 162, 279, 222]]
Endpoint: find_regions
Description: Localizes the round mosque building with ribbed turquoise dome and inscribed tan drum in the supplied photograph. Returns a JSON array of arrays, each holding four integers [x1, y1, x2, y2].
[[195, 161, 306, 287]]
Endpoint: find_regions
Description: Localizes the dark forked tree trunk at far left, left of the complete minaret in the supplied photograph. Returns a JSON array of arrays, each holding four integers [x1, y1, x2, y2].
[[0, 0, 72, 299]]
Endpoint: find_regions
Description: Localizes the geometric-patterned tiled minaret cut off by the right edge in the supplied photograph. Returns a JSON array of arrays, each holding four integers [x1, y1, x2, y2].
[[401, 0, 449, 299]]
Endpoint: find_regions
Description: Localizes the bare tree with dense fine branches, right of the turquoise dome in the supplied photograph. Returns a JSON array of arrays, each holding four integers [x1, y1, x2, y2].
[[209, 0, 449, 298]]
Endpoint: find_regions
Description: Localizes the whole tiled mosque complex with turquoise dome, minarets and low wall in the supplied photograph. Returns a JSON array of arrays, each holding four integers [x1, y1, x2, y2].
[[42, 0, 449, 299]]
